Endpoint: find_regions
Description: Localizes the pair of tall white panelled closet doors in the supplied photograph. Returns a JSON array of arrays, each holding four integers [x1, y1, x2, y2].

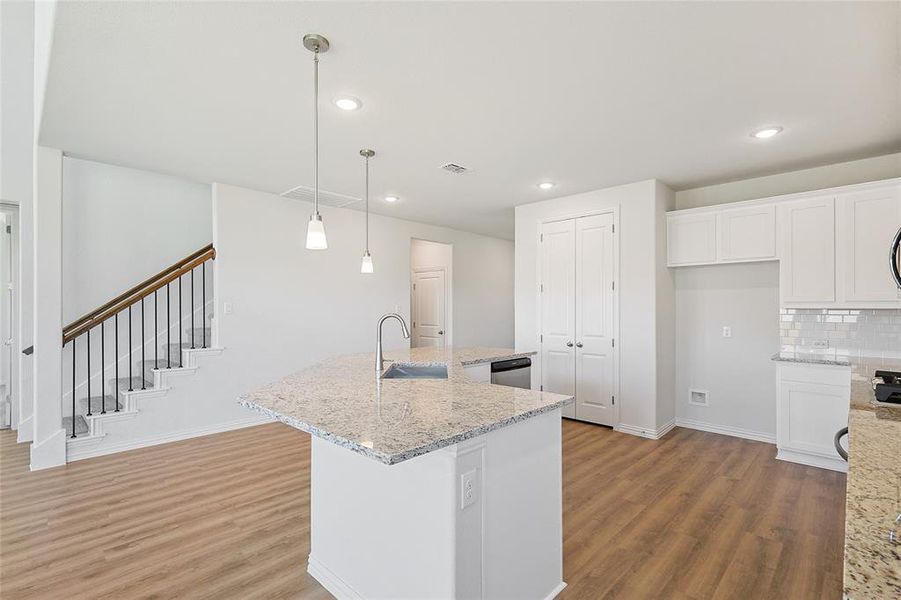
[[539, 213, 616, 425]]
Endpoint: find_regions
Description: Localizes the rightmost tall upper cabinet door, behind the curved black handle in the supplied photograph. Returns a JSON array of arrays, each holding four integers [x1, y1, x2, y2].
[[837, 184, 901, 307]]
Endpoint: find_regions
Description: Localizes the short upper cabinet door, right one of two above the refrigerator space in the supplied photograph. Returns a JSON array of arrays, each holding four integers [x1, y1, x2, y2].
[[716, 204, 776, 262]]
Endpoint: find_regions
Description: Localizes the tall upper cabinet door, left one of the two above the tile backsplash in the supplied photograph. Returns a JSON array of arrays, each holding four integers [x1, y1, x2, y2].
[[779, 196, 832, 304]]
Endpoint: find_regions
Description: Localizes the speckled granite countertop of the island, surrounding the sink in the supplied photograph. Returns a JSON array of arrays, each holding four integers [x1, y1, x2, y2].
[[238, 348, 573, 465]]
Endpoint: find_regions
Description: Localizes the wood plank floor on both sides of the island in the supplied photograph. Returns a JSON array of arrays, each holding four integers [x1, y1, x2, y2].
[[0, 421, 845, 600]]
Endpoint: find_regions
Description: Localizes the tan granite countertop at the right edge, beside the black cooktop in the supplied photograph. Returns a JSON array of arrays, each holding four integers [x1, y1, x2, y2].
[[844, 358, 901, 600]]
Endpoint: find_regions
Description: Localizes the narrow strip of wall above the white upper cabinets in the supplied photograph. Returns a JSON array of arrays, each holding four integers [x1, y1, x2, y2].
[[676, 151, 901, 210]]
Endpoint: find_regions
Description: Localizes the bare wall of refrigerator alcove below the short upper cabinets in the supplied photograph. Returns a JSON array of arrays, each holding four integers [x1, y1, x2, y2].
[[673, 261, 779, 439]]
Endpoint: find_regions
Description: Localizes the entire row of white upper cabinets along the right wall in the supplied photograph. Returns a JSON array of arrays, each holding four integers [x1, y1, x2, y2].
[[666, 179, 901, 308]]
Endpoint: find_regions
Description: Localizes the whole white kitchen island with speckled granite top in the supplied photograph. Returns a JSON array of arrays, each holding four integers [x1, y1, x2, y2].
[[239, 348, 572, 600]]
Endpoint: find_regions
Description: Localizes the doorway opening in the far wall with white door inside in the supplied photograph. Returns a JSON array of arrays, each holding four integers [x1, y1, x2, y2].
[[410, 239, 453, 349]]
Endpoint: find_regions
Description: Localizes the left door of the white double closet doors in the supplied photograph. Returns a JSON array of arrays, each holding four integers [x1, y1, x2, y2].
[[539, 219, 576, 418]]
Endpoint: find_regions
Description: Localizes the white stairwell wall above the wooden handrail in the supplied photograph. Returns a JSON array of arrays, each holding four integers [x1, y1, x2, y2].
[[63, 157, 213, 323]]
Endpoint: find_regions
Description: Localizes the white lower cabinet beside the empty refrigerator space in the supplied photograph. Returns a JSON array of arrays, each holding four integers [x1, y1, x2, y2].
[[776, 363, 851, 471]]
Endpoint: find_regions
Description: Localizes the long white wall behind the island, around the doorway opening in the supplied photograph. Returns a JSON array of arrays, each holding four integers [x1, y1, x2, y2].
[[207, 184, 513, 401]]
